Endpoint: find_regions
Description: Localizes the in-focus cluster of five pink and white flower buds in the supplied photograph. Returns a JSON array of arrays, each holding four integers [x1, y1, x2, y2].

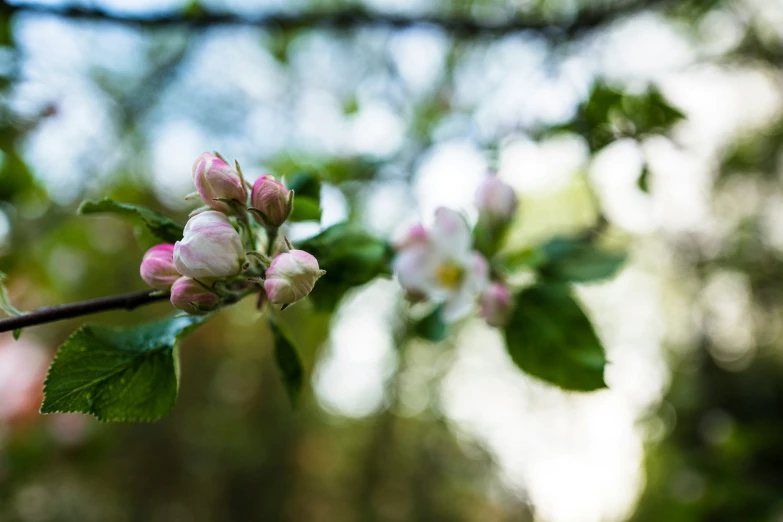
[[140, 152, 325, 314]]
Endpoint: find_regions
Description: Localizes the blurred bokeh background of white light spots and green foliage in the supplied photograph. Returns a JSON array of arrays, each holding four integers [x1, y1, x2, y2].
[[0, 0, 783, 522]]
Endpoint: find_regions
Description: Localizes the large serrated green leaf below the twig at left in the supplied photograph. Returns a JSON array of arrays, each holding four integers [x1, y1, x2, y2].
[[41, 316, 207, 422]]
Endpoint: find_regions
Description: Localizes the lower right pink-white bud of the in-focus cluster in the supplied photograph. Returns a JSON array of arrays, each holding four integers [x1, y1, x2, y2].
[[264, 250, 326, 305]]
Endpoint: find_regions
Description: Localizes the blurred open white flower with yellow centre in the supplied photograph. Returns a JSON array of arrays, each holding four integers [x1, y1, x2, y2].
[[394, 208, 489, 322]]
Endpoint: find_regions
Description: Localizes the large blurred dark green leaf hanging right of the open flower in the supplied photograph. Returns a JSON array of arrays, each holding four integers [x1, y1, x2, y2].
[[505, 285, 606, 391]]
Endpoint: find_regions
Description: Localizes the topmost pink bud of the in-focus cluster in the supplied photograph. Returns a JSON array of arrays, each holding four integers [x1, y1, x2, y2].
[[193, 152, 247, 213]]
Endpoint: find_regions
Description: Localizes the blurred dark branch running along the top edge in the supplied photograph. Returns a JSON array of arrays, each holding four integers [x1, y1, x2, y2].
[[0, 0, 676, 38]]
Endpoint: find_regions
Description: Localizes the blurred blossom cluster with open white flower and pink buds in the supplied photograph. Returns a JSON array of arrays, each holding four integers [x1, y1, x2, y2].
[[394, 176, 518, 327]]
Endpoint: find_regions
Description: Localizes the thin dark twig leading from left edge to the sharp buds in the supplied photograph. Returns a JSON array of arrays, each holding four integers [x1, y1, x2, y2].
[[0, 290, 169, 332]]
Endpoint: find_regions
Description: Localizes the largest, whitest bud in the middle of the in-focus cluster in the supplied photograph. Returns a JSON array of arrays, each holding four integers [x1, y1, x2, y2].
[[174, 210, 245, 278]]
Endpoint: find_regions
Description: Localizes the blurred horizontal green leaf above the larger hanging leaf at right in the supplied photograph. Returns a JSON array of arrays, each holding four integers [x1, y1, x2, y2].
[[539, 237, 626, 283]]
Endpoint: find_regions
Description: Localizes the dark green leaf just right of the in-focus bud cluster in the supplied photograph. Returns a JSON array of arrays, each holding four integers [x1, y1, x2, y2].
[[298, 223, 393, 310]]
